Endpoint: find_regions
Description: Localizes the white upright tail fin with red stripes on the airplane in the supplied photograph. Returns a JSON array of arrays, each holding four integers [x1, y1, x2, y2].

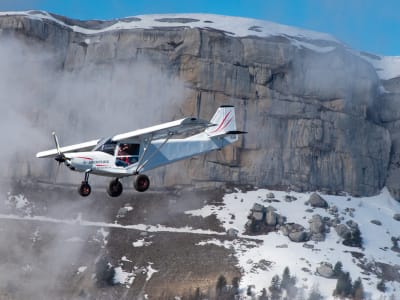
[[205, 105, 236, 136]]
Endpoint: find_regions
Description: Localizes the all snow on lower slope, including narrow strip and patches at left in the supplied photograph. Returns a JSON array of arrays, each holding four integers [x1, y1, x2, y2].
[[0, 189, 400, 299]]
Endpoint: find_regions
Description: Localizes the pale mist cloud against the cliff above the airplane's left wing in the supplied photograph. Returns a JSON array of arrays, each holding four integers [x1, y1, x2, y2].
[[0, 38, 185, 183]]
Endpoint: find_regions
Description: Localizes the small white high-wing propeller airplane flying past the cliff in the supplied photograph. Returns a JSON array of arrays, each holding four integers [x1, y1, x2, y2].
[[36, 105, 246, 197]]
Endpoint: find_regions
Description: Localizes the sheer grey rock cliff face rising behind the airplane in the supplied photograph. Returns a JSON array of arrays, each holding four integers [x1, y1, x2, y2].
[[0, 12, 394, 197]]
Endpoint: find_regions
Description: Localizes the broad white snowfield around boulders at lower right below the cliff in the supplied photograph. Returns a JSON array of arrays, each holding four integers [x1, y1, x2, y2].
[[187, 189, 400, 299]]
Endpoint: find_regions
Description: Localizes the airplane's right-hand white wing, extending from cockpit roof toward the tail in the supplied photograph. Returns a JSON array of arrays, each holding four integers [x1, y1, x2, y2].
[[112, 117, 214, 143]]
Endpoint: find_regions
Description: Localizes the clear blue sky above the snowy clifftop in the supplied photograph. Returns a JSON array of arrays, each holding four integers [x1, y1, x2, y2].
[[0, 0, 400, 56]]
